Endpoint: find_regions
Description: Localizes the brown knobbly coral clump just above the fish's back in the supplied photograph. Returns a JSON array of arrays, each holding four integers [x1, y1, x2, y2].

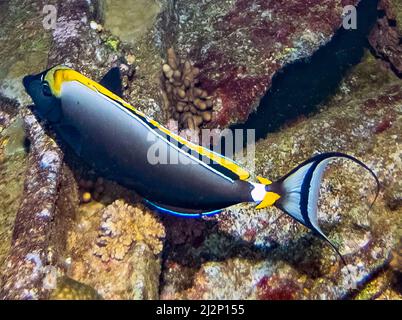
[[162, 48, 213, 131]]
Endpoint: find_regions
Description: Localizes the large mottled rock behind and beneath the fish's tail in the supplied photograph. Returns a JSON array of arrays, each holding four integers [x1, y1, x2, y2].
[[161, 54, 402, 299]]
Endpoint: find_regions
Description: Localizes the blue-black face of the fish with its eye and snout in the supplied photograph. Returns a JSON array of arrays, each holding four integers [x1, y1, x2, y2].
[[22, 68, 62, 123]]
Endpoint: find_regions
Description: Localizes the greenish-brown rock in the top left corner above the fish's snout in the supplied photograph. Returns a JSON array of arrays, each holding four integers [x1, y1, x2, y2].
[[0, 0, 52, 104]]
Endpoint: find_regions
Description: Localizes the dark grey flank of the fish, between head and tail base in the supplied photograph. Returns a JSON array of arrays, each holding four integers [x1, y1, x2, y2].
[[53, 82, 253, 212]]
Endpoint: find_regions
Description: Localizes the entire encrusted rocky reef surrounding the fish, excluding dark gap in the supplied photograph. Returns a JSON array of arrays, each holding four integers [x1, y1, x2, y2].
[[0, 0, 402, 299]]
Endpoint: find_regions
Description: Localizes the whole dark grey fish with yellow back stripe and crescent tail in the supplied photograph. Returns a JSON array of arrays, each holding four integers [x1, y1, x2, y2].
[[23, 66, 380, 258]]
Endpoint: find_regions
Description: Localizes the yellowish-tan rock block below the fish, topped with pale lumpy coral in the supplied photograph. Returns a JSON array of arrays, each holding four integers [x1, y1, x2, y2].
[[66, 200, 165, 299]]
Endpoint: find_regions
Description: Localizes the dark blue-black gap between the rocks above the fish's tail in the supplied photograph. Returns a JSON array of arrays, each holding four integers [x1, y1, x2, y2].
[[230, 0, 381, 146]]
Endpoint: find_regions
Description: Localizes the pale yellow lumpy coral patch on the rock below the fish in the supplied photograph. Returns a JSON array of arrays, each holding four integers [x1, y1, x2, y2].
[[94, 200, 165, 261]]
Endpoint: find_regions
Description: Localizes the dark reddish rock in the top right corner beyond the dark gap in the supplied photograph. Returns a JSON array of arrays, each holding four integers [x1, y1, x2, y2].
[[369, 0, 402, 75]]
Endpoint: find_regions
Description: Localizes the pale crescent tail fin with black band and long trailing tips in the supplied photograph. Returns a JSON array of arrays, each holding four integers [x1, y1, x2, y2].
[[269, 152, 380, 265]]
